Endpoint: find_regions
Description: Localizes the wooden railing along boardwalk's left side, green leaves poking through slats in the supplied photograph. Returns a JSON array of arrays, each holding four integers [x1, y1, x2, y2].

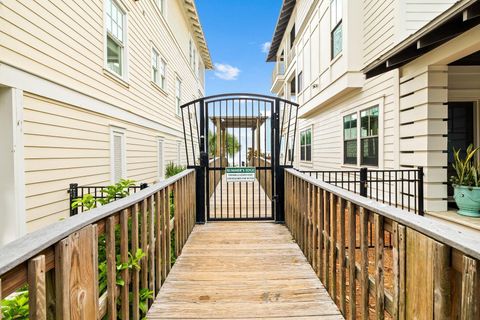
[[0, 170, 196, 319]]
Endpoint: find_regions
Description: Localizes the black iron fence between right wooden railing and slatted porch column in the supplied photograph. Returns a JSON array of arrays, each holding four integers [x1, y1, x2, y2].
[[297, 167, 424, 216]]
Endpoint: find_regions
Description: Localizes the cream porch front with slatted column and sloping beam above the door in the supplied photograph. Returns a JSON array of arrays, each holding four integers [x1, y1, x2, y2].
[[400, 26, 480, 212]]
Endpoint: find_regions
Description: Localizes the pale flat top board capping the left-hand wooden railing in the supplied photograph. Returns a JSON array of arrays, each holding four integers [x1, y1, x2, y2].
[[0, 169, 194, 275]]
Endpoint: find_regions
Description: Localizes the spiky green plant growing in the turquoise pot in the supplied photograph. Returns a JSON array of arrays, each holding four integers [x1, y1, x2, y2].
[[450, 144, 480, 187]]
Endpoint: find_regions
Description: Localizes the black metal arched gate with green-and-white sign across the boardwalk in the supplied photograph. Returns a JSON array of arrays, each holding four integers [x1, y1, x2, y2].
[[181, 94, 298, 223]]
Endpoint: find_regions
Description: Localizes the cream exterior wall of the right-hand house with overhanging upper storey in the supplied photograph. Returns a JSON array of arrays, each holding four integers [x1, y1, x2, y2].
[[274, 0, 455, 210]]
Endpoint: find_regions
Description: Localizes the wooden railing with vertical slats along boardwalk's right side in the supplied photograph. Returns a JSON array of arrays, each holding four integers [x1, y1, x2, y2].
[[285, 169, 480, 320]]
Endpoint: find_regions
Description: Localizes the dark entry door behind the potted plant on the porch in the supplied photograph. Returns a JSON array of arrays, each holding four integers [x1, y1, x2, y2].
[[448, 102, 475, 205]]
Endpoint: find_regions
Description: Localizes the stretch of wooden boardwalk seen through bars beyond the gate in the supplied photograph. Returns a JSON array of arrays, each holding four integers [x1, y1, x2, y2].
[[210, 175, 273, 219]]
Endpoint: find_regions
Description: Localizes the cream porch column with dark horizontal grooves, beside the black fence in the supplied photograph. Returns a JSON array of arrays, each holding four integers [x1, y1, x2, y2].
[[399, 65, 448, 211]]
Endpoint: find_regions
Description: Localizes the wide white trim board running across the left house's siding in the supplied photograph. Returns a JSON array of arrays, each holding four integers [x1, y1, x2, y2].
[[0, 63, 183, 137]]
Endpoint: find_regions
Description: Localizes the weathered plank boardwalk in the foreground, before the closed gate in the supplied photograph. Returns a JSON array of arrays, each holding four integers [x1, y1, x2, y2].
[[147, 222, 343, 320]]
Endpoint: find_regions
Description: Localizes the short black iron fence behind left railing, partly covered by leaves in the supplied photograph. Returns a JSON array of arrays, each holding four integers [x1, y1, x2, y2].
[[68, 183, 148, 216]]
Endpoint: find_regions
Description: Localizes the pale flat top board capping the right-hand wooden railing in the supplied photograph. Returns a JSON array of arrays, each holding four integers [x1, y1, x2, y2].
[[286, 169, 480, 259]]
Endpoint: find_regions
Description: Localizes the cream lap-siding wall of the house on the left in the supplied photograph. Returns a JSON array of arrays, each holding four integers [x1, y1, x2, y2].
[[0, 0, 206, 241]]
